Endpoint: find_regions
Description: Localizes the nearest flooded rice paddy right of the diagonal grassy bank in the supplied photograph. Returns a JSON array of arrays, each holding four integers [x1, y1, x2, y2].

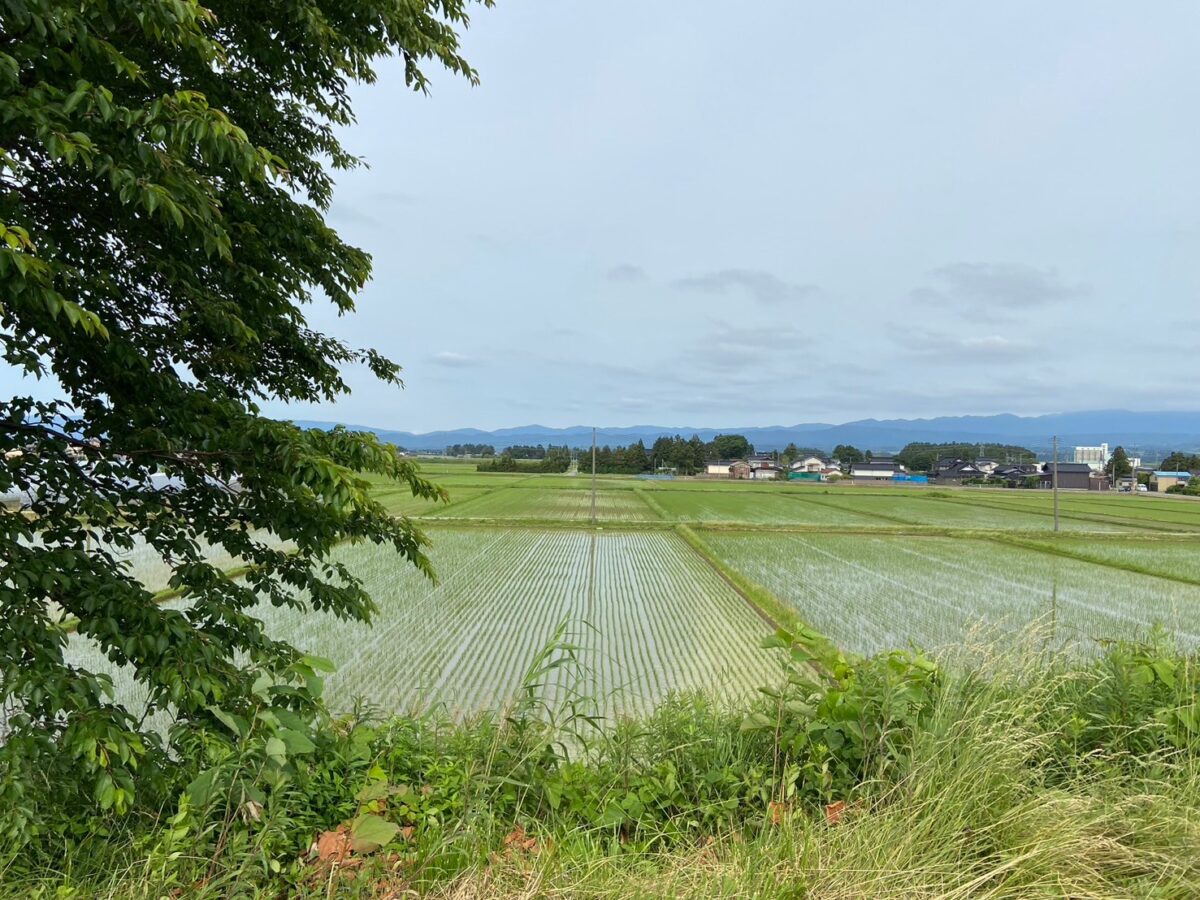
[[706, 533, 1200, 652]]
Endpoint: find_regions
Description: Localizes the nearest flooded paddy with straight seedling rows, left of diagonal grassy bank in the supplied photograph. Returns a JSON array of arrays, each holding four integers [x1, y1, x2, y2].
[[72, 528, 775, 715]]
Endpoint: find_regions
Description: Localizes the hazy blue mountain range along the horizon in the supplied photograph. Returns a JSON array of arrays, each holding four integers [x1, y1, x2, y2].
[[288, 409, 1200, 460]]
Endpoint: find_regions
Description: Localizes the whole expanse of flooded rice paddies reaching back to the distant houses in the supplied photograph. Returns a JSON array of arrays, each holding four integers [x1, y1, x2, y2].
[[72, 472, 1200, 715]]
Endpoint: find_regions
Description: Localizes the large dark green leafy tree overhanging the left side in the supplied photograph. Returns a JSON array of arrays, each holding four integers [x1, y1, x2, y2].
[[0, 0, 487, 839]]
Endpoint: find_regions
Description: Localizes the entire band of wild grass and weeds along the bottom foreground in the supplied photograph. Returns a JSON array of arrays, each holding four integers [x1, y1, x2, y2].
[[0, 630, 1200, 900]]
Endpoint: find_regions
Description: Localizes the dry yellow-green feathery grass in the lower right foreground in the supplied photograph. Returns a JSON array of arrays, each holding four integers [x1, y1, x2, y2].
[[436, 638, 1200, 898]]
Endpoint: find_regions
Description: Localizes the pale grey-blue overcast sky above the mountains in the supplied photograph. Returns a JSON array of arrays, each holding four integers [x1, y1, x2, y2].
[[9, 0, 1200, 431]]
